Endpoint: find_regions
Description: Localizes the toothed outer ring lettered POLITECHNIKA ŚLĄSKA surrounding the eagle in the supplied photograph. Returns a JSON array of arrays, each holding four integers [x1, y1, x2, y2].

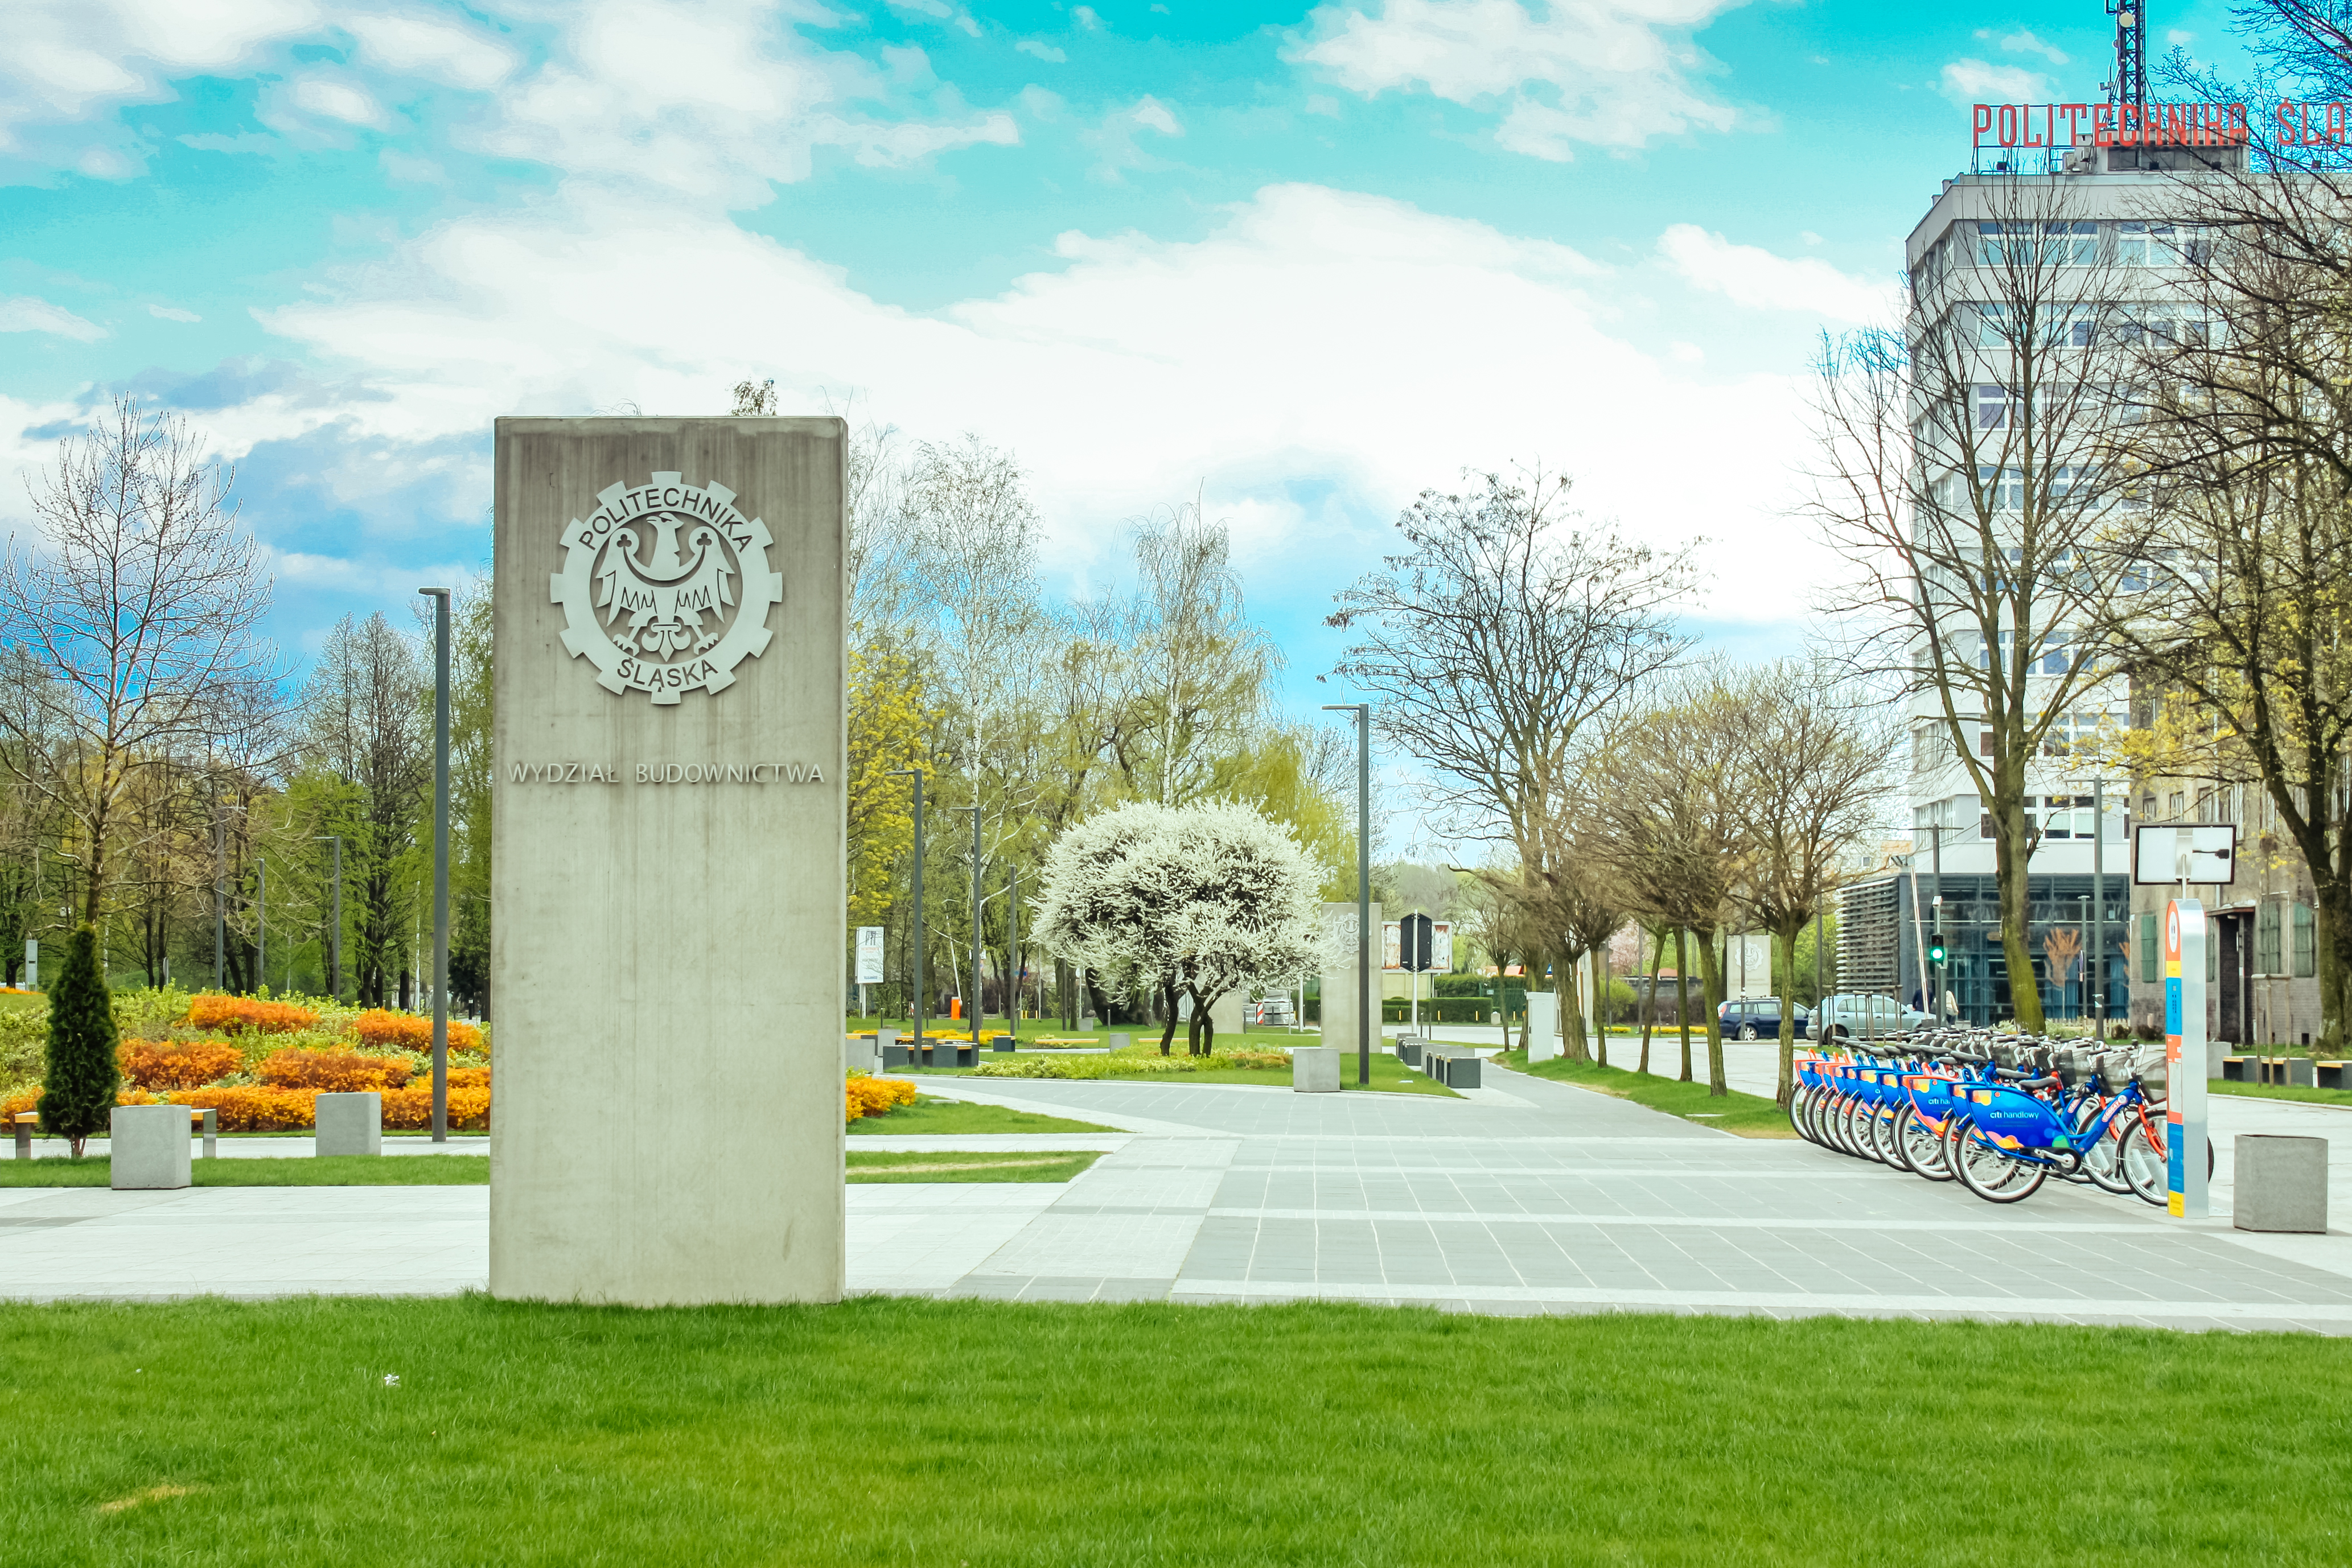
[[548, 472, 783, 707]]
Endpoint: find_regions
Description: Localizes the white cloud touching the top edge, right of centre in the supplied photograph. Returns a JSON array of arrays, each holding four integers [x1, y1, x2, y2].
[[1294, 0, 1743, 160]]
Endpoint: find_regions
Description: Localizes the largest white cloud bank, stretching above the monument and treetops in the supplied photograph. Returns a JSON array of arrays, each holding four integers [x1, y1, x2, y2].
[[207, 186, 1820, 620]]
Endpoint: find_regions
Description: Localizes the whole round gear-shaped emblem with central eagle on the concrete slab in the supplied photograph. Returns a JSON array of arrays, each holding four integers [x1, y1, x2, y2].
[[550, 472, 783, 705]]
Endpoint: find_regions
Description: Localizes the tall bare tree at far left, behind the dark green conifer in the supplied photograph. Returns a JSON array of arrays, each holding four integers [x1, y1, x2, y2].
[[0, 395, 275, 926]]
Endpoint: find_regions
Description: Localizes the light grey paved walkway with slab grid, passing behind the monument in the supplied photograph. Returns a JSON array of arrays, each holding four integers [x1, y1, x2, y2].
[[0, 1063, 2352, 1333]]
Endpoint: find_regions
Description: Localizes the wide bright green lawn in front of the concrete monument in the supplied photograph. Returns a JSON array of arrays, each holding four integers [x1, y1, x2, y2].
[[0, 1295, 2352, 1568]]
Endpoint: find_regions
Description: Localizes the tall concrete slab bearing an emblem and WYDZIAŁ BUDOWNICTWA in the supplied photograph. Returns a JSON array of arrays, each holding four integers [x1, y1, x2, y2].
[[489, 418, 847, 1304]]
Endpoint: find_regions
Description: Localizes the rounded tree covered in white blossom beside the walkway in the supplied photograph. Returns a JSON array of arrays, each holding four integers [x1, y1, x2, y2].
[[1037, 801, 1322, 1056]]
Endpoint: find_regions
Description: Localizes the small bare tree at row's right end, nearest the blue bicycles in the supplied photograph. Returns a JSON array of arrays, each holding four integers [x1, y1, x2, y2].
[[1729, 659, 1901, 1105]]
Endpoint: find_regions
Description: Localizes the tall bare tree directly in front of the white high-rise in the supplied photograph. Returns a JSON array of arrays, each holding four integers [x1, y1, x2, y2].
[[1809, 179, 2140, 1030]]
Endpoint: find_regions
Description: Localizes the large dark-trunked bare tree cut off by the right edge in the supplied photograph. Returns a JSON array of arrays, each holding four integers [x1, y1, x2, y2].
[[2112, 169, 2352, 1053]]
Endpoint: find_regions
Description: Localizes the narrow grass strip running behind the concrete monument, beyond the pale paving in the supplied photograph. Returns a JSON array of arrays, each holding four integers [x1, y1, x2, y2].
[[0, 1151, 1101, 1190]]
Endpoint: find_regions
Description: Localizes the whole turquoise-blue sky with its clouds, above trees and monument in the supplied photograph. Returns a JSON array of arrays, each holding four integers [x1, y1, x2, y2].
[[0, 0, 2230, 707]]
